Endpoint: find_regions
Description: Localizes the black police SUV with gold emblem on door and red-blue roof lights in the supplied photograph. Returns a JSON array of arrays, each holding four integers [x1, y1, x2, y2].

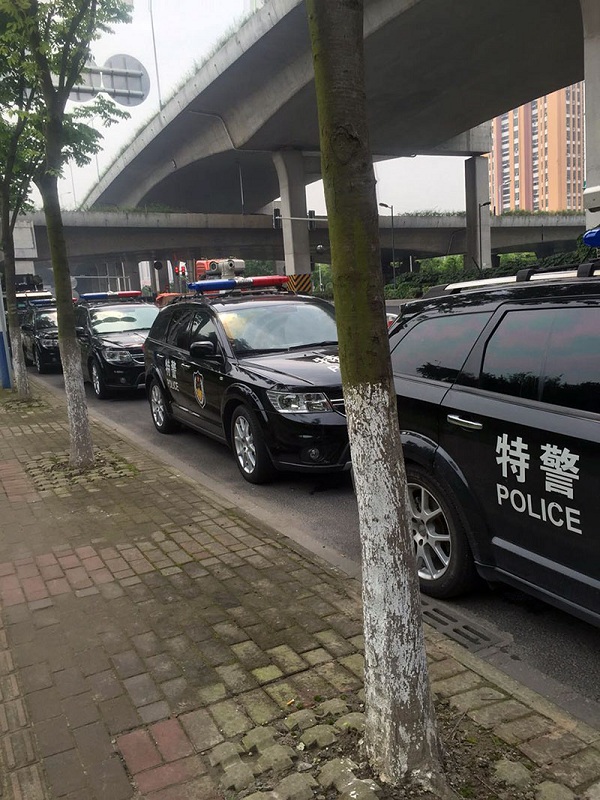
[[145, 276, 350, 483]]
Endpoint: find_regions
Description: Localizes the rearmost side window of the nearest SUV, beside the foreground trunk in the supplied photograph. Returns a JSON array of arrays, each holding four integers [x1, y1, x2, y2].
[[392, 312, 490, 382]]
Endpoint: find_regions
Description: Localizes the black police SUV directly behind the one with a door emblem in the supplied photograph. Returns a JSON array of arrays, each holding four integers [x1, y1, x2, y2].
[[75, 291, 158, 399]]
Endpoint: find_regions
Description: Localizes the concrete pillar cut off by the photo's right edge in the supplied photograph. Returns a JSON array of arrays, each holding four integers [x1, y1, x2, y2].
[[579, 0, 600, 230]]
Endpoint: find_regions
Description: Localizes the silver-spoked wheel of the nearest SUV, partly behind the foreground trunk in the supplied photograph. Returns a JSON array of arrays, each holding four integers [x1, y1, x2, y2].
[[406, 464, 477, 598]]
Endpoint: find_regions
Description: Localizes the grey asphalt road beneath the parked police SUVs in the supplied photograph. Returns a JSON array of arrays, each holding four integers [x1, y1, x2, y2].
[[36, 374, 600, 727]]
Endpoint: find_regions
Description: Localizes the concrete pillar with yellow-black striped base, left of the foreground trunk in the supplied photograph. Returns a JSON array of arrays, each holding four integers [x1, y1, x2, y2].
[[273, 150, 311, 292]]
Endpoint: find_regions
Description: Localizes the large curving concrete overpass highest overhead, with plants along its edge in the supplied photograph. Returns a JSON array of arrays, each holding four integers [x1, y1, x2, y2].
[[85, 0, 594, 213]]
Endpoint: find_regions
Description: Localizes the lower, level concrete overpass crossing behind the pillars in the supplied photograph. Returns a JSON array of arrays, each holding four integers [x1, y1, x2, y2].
[[17, 211, 585, 282]]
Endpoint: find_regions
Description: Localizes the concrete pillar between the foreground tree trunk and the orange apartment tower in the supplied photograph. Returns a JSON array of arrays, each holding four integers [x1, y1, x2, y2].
[[465, 156, 492, 270]]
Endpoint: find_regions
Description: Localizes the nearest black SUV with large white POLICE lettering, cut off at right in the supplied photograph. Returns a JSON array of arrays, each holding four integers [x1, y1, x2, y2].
[[390, 261, 600, 625]]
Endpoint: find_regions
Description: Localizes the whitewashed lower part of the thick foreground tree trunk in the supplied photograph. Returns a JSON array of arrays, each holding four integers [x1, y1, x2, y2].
[[344, 384, 445, 796]]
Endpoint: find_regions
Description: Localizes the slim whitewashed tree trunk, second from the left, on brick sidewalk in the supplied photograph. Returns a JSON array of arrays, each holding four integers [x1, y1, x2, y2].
[[36, 170, 94, 469]]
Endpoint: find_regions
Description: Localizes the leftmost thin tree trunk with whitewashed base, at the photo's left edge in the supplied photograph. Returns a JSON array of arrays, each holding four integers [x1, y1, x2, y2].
[[0, 186, 31, 400]]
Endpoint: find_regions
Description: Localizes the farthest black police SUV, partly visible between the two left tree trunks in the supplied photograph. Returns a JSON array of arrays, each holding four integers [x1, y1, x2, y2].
[[20, 299, 61, 373]]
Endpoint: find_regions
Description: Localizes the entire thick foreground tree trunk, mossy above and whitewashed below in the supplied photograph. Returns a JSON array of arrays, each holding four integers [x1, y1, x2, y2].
[[307, 0, 453, 797]]
